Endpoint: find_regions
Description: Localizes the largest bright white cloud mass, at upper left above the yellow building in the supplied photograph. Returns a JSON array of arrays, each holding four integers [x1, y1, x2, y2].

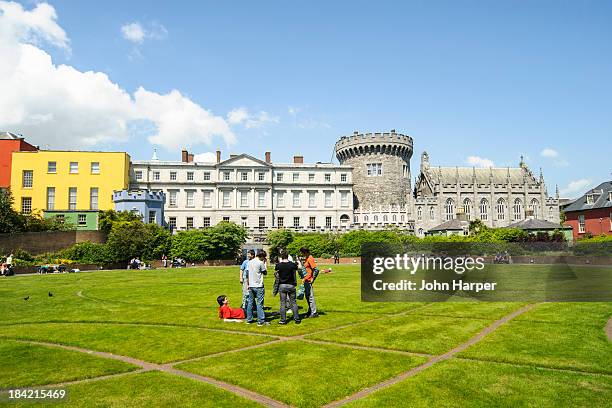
[[0, 1, 236, 149]]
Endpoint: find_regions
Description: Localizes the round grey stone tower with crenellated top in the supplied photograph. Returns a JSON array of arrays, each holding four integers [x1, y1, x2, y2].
[[335, 130, 412, 209]]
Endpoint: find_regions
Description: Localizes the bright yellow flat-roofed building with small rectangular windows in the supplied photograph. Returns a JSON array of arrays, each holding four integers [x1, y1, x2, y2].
[[11, 150, 130, 229]]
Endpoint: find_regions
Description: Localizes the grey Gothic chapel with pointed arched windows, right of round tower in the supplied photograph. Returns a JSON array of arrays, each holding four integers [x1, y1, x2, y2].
[[413, 152, 560, 235]]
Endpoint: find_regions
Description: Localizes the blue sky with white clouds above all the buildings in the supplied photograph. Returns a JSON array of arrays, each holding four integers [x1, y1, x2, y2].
[[0, 0, 612, 197]]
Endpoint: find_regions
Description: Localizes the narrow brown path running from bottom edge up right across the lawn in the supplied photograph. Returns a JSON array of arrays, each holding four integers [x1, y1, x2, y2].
[[325, 304, 535, 408]]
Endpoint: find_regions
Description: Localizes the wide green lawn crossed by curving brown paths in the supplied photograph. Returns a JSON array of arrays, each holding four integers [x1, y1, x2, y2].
[[0, 265, 612, 407]]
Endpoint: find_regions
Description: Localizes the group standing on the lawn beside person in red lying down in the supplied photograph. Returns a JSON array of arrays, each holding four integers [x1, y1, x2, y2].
[[217, 248, 319, 326]]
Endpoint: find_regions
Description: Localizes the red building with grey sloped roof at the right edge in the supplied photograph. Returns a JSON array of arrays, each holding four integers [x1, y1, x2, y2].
[[564, 181, 612, 239]]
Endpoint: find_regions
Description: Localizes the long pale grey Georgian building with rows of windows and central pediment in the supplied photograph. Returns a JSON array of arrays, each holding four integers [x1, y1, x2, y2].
[[130, 150, 353, 231]]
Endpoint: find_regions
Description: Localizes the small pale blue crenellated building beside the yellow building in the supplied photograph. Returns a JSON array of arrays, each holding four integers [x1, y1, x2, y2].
[[113, 190, 166, 226]]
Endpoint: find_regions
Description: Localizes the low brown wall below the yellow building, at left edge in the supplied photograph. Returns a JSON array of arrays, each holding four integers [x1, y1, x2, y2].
[[0, 231, 106, 255]]
